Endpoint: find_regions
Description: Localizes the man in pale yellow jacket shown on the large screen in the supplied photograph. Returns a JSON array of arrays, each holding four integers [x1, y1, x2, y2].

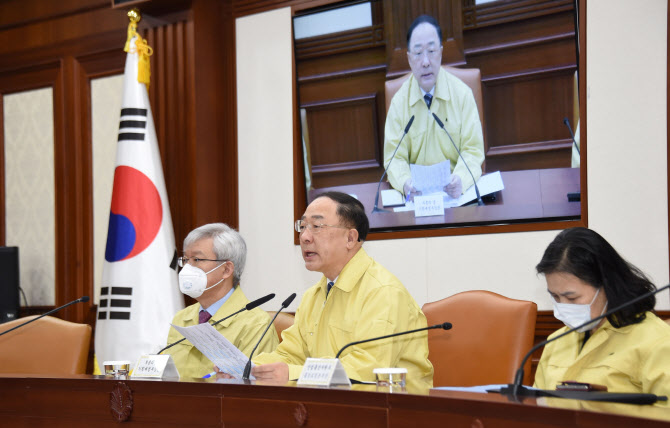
[[384, 15, 484, 198]]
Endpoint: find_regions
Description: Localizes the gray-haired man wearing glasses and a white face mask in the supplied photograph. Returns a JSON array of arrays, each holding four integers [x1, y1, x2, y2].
[[166, 223, 279, 378]]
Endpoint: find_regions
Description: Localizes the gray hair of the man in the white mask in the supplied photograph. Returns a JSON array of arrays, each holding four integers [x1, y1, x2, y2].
[[184, 223, 247, 285]]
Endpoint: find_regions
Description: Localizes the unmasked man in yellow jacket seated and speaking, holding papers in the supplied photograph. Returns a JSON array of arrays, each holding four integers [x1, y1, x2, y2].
[[252, 192, 433, 390]]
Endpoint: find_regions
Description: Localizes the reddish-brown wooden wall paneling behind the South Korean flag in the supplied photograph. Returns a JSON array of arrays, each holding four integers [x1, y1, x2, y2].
[[0, 0, 237, 332]]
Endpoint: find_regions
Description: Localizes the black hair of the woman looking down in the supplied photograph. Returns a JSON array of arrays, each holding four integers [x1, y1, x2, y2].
[[536, 227, 656, 328]]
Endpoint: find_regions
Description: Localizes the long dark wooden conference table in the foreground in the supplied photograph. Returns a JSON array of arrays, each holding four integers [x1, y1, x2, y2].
[[0, 374, 670, 427]]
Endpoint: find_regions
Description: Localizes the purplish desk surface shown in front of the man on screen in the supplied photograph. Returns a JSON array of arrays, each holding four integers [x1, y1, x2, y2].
[[308, 168, 581, 231]]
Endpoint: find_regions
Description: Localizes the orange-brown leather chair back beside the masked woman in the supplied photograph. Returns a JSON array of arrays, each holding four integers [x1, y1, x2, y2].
[[422, 290, 537, 387]]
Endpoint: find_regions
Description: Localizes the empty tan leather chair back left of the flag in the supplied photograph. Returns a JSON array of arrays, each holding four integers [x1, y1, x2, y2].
[[0, 316, 91, 375]]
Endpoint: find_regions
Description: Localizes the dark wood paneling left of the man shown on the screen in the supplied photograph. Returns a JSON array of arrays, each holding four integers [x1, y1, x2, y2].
[[295, 1, 386, 187]]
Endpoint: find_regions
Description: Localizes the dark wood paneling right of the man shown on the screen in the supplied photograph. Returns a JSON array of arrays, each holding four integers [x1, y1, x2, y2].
[[464, 7, 577, 171]]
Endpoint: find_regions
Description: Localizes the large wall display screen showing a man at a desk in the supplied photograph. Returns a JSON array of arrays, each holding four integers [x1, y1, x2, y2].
[[293, 0, 583, 233]]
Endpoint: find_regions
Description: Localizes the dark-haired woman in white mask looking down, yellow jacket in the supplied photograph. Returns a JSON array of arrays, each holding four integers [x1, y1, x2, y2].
[[535, 228, 670, 407]]
